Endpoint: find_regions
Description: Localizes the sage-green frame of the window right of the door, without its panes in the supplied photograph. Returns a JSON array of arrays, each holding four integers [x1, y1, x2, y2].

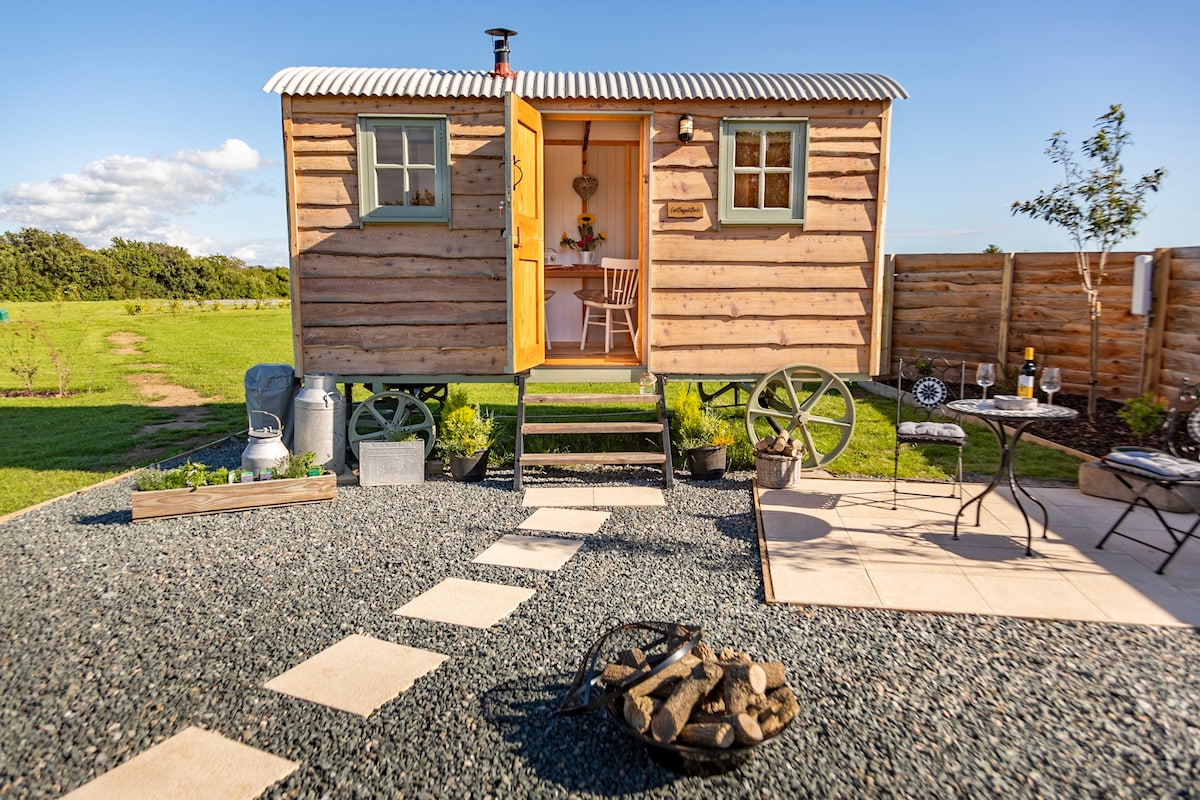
[[716, 116, 809, 227]]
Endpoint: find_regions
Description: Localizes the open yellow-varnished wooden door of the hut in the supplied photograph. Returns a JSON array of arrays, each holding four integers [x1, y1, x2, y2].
[[504, 92, 546, 373]]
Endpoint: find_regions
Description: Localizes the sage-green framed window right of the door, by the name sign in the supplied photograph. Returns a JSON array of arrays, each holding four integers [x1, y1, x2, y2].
[[718, 119, 809, 224]]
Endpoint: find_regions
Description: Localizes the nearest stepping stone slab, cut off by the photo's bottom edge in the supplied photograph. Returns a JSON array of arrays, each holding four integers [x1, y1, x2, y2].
[[64, 728, 300, 800]]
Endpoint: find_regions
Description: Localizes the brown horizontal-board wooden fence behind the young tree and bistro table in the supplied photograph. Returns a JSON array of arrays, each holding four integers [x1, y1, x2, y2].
[[886, 247, 1200, 401]]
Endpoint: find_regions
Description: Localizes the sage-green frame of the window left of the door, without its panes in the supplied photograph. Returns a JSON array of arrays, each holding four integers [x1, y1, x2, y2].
[[358, 114, 450, 223]]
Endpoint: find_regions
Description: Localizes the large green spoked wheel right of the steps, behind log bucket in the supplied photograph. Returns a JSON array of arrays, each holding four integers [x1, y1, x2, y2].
[[746, 363, 854, 469]]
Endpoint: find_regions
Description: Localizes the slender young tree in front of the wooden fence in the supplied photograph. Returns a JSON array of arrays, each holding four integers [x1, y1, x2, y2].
[[1013, 106, 1166, 417]]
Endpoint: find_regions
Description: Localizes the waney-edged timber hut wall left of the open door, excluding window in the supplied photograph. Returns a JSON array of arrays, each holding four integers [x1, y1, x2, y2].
[[284, 97, 508, 375]]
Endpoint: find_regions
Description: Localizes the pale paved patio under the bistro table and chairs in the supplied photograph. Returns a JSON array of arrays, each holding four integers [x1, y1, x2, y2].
[[756, 476, 1200, 627]]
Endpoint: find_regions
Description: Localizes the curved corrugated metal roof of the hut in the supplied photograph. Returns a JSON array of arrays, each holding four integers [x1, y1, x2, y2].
[[263, 67, 908, 101]]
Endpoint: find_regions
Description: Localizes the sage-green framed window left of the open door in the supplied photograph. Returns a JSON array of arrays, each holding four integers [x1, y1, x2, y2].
[[359, 116, 450, 222]]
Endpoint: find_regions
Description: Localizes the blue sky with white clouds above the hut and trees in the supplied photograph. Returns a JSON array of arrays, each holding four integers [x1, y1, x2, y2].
[[0, 0, 1200, 265]]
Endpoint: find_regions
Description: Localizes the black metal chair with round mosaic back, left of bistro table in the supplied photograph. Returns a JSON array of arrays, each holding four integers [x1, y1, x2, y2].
[[892, 356, 967, 509]]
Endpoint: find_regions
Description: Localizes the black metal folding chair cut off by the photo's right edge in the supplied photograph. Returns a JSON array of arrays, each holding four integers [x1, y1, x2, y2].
[[1096, 379, 1200, 575]]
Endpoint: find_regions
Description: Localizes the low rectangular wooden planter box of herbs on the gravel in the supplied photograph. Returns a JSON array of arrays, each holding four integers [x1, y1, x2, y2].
[[132, 473, 337, 522]]
